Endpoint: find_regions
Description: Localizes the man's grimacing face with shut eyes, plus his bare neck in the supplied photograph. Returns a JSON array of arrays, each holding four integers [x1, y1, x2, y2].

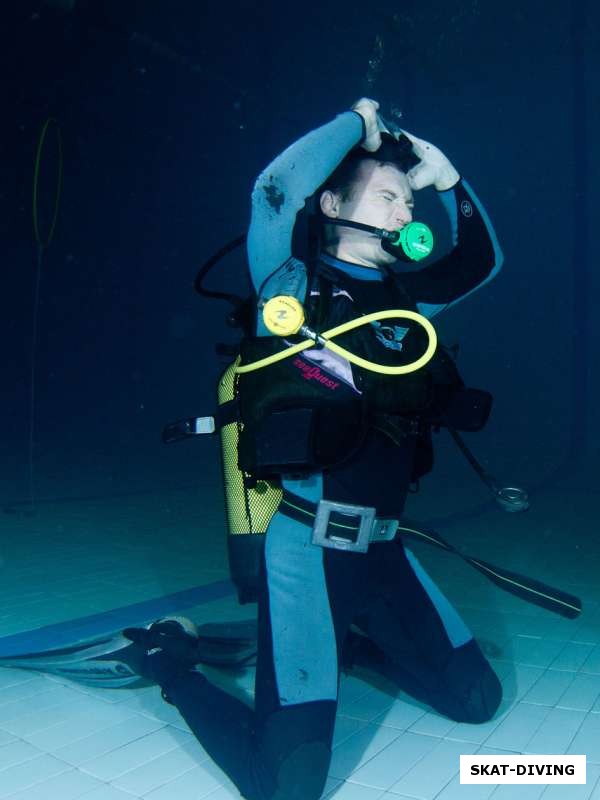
[[321, 160, 414, 267]]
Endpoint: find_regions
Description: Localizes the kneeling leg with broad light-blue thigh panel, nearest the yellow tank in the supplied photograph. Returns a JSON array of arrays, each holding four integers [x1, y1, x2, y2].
[[135, 506, 338, 800]]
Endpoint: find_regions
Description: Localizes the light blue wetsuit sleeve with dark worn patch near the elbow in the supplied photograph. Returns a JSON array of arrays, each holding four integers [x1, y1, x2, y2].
[[248, 111, 364, 294]]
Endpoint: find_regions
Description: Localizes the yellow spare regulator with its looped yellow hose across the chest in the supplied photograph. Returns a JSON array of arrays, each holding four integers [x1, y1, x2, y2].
[[235, 296, 437, 375]]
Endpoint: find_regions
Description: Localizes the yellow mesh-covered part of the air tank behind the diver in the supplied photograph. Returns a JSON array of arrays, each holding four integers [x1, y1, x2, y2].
[[217, 357, 282, 535]]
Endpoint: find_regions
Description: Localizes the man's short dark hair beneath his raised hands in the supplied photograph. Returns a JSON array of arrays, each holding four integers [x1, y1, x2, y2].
[[319, 132, 419, 200]]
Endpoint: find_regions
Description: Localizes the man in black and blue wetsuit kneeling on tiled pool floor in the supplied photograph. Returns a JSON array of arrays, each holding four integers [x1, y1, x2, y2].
[[124, 98, 502, 800]]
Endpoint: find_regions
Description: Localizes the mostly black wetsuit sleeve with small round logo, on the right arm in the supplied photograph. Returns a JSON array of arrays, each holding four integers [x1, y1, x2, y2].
[[402, 180, 503, 317]]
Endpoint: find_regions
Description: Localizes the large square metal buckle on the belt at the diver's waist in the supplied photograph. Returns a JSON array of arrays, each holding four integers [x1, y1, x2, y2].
[[312, 500, 375, 553]]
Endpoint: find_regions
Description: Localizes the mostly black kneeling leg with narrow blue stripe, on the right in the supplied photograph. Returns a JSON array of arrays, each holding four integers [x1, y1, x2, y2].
[[345, 542, 502, 722]]
